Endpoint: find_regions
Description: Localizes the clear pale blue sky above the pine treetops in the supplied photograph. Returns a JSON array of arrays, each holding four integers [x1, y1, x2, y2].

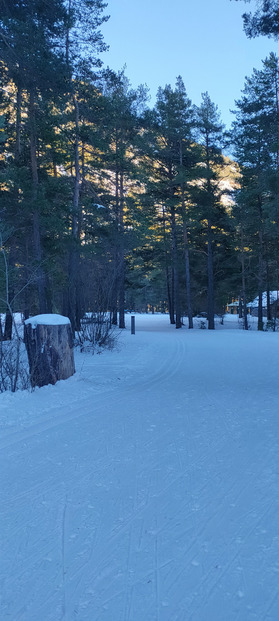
[[102, 0, 279, 126]]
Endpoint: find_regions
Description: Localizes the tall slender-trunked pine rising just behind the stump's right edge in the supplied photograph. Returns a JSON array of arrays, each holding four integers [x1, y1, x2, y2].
[[64, 0, 108, 331]]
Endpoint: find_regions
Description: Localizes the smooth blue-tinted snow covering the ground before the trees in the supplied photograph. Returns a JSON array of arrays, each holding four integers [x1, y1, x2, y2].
[[0, 315, 279, 621]]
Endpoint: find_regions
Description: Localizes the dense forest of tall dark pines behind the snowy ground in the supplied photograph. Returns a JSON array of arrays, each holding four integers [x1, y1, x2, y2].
[[0, 0, 279, 340]]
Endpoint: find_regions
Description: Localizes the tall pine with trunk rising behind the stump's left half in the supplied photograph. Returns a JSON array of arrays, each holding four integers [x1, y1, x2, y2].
[[0, 0, 69, 312]]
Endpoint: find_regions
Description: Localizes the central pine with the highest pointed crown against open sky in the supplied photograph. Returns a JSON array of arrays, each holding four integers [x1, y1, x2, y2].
[[141, 77, 196, 328]]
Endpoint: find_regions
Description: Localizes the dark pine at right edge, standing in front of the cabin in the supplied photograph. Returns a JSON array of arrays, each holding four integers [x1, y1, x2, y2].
[[233, 54, 279, 329]]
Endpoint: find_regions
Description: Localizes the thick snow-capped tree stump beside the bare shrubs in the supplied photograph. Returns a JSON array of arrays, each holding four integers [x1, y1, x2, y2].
[[24, 314, 75, 387]]
